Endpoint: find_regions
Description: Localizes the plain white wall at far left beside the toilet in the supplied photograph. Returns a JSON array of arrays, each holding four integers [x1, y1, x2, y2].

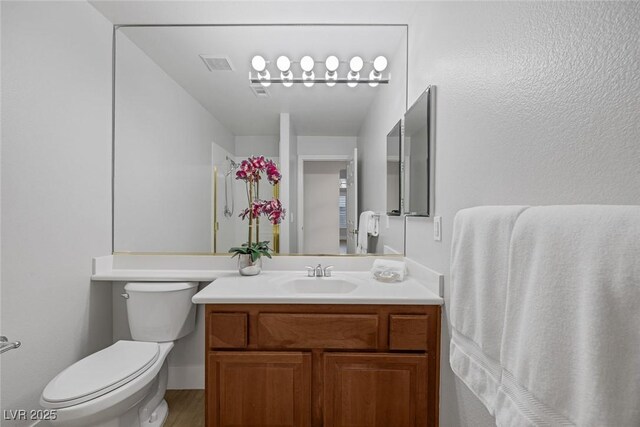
[[0, 1, 112, 427]]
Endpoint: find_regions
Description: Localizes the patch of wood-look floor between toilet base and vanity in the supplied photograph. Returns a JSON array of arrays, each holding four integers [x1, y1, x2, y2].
[[164, 390, 204, 427]]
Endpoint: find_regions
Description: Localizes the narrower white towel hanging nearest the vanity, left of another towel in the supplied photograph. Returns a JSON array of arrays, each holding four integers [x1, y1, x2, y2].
[[449, 206, 527, 414]]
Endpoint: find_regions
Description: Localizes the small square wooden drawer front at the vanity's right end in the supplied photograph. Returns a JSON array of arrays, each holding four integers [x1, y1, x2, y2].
[[389, 314, 433, 350]]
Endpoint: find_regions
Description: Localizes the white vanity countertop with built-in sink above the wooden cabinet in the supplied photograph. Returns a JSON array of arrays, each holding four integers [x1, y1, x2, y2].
[[192, 271, 443, 305]]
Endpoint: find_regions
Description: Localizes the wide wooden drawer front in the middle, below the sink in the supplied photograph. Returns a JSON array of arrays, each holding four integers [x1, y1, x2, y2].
[[258, 313, 378, 350]]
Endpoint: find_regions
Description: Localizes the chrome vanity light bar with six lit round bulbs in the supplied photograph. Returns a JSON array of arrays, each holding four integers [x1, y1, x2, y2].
[[249, 55, 390, 87]]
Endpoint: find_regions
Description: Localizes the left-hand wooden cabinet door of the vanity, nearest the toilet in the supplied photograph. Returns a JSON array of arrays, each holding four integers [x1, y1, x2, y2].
[[207, 351, 311, 427]]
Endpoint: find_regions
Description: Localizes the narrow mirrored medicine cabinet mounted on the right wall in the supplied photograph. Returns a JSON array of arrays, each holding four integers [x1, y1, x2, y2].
[[402, 87, 435, 216]]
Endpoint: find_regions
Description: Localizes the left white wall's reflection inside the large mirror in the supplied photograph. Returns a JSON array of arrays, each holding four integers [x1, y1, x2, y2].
[[114, 33, 235, 252]]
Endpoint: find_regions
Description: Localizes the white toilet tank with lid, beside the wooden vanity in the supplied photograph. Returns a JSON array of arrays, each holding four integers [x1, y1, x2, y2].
[[124, 282, 198, 342]]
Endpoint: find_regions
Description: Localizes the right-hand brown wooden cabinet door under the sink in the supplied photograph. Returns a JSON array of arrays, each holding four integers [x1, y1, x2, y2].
[[324, 353, 428, 427]]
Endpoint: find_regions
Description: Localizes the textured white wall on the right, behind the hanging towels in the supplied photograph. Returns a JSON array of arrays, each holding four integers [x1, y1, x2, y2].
[[361, 2, 640, 427]]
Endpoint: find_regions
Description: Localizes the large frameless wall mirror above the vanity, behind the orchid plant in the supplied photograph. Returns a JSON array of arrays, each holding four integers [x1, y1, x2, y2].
[[113, 25, 407, 254]]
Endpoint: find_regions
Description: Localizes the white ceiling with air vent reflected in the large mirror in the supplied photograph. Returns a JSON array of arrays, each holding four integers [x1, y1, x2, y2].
[[116, 26, 406, 136]]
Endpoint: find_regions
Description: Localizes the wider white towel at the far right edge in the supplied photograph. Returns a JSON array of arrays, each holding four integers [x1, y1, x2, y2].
[[495, 206, 640, 427]]
